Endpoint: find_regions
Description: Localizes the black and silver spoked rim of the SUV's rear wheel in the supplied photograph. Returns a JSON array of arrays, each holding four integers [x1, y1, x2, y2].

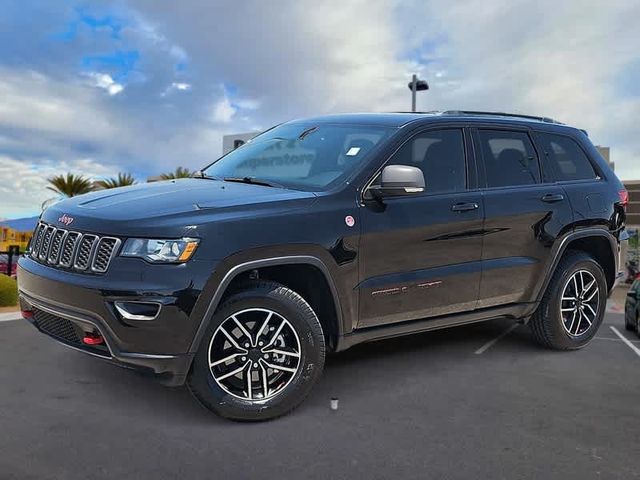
[[560, 270, 600, 337]]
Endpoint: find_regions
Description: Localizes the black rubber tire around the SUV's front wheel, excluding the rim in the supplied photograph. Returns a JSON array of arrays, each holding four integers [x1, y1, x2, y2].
[[189, 287, 324, 420]]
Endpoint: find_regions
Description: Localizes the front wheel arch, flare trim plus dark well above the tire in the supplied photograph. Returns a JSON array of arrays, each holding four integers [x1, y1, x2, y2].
[[189, 255, 344, 352]]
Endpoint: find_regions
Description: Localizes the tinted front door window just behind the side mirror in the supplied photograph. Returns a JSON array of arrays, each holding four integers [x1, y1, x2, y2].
[[388, 129, 466, 193]]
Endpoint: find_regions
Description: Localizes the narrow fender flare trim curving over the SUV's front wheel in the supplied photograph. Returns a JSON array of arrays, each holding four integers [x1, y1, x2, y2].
[[189, 255, 344, 353]]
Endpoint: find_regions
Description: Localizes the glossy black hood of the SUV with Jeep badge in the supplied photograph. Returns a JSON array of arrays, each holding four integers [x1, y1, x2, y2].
[[42, 178, 316, 234]]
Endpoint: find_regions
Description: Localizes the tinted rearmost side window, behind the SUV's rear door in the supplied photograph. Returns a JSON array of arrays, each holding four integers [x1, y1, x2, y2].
[[537, 133, 598, 181]]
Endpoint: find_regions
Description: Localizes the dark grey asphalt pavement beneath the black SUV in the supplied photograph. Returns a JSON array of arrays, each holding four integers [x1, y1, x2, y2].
[[0, 313, 640, 480]]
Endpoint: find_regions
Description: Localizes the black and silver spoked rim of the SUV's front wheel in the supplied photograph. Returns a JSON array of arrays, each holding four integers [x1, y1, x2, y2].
[[209, 308, 301, 401]]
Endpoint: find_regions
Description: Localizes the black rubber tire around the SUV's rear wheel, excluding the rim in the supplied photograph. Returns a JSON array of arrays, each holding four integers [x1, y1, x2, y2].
[[545, 256, 607, 349]]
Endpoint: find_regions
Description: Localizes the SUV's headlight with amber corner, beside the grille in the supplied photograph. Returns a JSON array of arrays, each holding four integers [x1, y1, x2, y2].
[[120, 238, 200, 263]]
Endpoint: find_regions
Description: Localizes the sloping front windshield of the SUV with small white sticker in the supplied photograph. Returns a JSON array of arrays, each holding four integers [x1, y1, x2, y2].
[[202, 124, 394, 191]]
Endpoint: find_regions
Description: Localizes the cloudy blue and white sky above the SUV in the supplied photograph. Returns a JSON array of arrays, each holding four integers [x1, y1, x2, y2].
[[0, 0, 640, 218]]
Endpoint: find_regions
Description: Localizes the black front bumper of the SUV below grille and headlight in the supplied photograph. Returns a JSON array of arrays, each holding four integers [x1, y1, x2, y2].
[[18, 257, 210, 385]]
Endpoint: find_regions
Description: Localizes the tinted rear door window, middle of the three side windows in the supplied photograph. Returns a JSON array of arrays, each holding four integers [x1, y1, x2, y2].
[[478, 130, 540, 187]]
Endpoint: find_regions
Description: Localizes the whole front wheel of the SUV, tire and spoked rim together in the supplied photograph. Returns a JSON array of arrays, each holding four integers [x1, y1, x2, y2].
[[187, 281, 325, 421]]
